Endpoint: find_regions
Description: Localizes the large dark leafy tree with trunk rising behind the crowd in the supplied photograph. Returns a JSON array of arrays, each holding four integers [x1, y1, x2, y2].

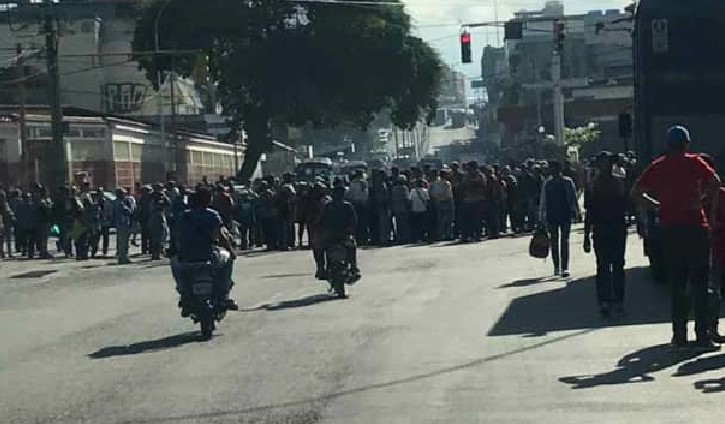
[[134, 0, 442, 180]]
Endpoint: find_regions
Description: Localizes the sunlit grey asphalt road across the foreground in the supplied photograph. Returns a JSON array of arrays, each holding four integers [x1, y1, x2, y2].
[[0, 234, 725, 424]]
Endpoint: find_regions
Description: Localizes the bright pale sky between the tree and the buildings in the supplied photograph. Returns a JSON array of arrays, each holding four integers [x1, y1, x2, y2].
[[403, 0, 631, 78]]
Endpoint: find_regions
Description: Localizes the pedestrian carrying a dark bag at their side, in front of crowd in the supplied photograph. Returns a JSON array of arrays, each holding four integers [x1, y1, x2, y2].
[[539, 161, 579, 278]]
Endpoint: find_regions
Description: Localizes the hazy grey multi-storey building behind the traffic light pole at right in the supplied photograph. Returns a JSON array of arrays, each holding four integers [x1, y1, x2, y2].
[[481, 1, 634, 159]]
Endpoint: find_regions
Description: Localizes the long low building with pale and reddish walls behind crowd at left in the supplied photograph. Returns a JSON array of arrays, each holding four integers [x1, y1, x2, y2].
[[0, 113, 244, 188]]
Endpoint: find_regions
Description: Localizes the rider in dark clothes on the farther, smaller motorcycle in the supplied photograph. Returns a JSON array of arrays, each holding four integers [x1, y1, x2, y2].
[[321, 186, 361, 280]]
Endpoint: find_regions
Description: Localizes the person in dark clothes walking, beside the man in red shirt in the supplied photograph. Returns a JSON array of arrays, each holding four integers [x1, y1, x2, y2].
[[584, 152, 629, 317]]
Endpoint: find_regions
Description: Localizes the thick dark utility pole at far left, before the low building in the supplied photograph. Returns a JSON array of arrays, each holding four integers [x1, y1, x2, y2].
[[44, 1, 68, 187]]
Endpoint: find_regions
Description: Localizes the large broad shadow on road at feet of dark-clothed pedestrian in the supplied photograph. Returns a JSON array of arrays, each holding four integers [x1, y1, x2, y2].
[[488, 268, 670, 337]]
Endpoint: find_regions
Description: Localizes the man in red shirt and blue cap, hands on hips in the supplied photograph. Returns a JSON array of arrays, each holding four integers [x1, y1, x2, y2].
[[632, 126, 720, 349]]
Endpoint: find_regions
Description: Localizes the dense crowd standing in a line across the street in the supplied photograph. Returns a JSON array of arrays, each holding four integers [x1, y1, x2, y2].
[[0, 152, 632, 268]]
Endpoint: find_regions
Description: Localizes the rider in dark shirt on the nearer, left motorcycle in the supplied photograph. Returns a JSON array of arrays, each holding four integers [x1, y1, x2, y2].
[[171, 187, 238, 317]]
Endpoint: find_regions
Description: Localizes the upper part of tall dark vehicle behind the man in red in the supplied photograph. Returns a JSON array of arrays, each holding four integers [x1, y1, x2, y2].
[[634, 0, 725, 165]]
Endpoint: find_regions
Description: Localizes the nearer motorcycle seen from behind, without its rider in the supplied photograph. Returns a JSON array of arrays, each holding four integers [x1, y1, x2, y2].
[[187, 263, 227, 340]]
